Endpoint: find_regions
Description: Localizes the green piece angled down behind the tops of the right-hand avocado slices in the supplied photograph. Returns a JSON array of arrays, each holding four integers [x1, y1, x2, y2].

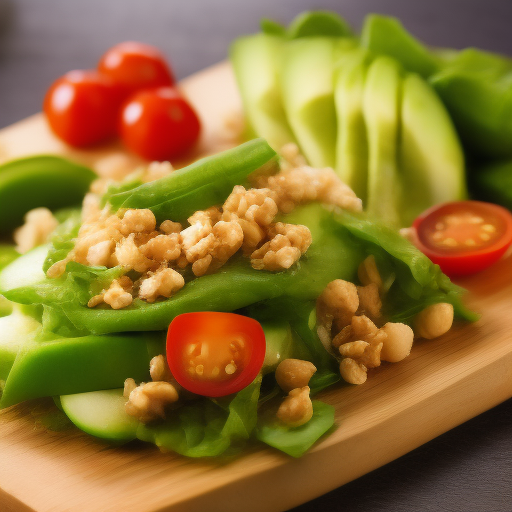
[[361, 14, 440, 78]]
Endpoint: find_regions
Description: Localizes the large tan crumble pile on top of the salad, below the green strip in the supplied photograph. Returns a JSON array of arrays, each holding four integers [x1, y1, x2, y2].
[[42, 144, 362, 309]]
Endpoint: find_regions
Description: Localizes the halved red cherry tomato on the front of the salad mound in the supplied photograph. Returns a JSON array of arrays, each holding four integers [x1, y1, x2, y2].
[[167, 311, 266, 396]]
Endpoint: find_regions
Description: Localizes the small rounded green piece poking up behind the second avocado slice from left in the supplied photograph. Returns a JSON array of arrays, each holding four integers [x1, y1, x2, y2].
[[288, 11, 353, 39]]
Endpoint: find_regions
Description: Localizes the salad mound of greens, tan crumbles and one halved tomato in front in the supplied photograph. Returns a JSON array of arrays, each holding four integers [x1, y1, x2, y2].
[[0, 139, 474, 457]]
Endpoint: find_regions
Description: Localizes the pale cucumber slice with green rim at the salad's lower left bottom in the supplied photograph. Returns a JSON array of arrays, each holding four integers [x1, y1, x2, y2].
[[60, 389, 139, 442]]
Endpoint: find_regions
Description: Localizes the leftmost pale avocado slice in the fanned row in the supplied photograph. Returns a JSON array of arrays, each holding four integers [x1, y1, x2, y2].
[[230, 34, 295, 150]]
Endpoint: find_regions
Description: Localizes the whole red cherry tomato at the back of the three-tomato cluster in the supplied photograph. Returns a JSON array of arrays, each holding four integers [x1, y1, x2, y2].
[[98, 41, 174, 93]]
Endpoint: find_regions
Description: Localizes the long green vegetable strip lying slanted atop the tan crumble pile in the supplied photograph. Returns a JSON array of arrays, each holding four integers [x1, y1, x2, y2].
[[105, 139, 276, 222]]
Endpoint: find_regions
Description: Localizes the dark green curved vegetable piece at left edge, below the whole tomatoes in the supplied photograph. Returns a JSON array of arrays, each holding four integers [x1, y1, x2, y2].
[[0, 155, 96, 234]]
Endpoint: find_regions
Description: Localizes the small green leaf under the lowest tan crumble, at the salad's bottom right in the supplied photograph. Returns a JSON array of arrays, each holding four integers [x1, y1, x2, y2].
[[256, 400, 335, 457]]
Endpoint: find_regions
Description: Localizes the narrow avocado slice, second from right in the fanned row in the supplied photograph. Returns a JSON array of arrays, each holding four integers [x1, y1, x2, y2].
[[363, 57, 401, 226]]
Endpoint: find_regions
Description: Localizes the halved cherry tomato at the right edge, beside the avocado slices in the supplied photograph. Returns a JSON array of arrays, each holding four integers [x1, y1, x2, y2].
[[412, 201, 512, 276]]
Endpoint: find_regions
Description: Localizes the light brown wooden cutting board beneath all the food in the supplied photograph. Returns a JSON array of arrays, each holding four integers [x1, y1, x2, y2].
[[0, 64, 512, 512]]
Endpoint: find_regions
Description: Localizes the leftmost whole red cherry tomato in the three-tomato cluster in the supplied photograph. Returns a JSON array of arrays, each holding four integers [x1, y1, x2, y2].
[[43, 71, 122, 147]]
